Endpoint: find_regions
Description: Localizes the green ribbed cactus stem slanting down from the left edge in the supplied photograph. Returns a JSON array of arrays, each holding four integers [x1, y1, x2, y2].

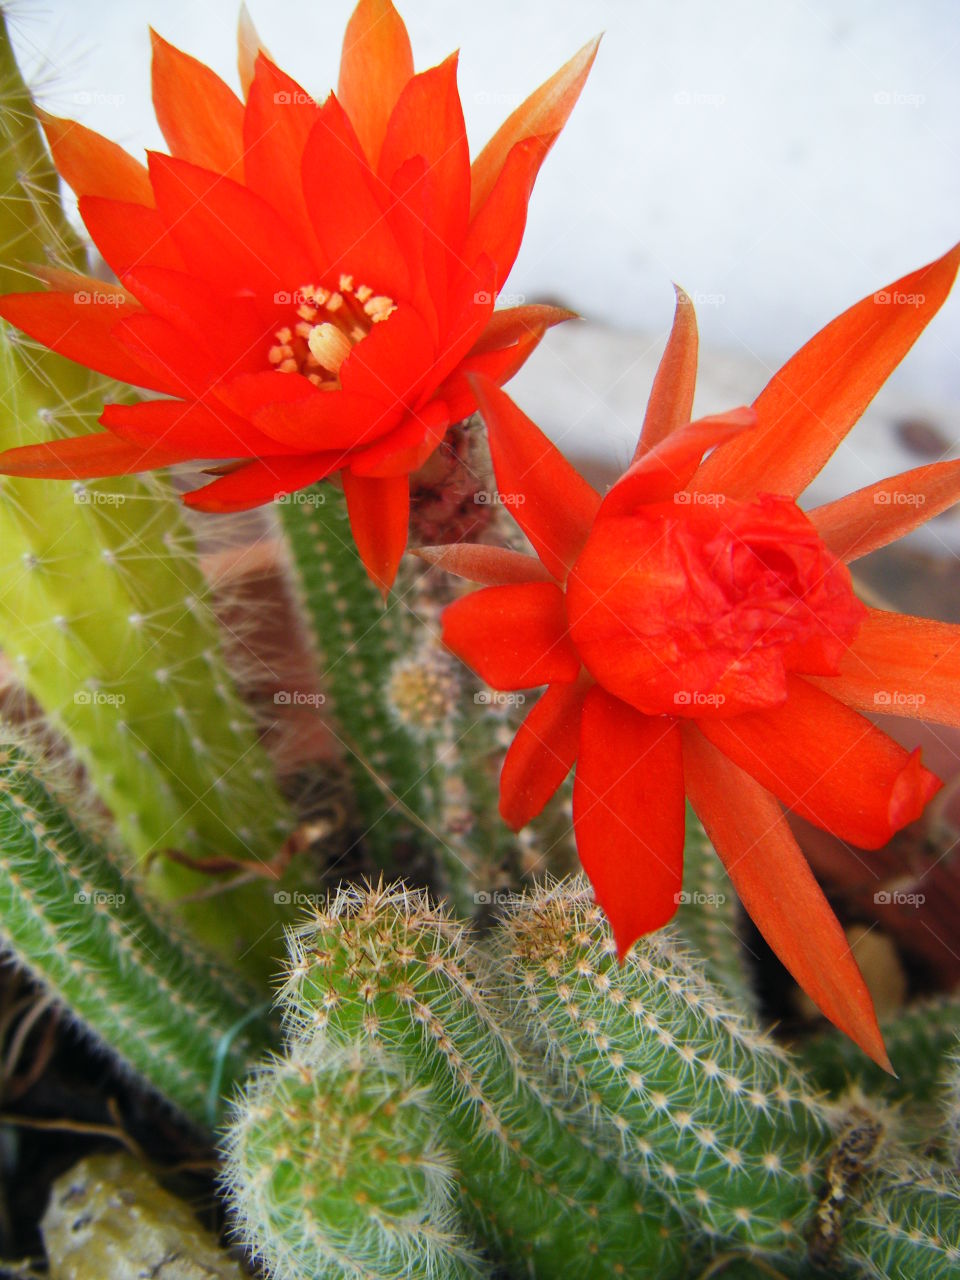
[[0, 737, 271, 1125]]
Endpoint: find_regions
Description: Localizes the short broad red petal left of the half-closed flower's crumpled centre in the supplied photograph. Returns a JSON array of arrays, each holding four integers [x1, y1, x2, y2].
[[443, 582, 580, 689]]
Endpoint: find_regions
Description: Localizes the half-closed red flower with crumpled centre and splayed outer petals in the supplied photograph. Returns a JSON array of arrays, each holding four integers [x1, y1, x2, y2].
[[420, 247, 960, 1066]]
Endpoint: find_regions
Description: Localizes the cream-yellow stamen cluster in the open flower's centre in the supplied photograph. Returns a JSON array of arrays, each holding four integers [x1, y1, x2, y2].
[[266, 275, 397, 390]]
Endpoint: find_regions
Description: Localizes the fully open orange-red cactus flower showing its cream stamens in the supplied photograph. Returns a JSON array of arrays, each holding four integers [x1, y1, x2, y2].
[[0, 0, 596, 590]]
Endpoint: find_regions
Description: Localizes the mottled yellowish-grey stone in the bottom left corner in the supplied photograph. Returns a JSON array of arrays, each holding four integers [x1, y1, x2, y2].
[[40, 1153, 246, 1280]]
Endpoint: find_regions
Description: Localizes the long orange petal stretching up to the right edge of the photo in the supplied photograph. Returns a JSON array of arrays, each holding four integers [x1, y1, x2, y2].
[[696, 244, 960, 500]]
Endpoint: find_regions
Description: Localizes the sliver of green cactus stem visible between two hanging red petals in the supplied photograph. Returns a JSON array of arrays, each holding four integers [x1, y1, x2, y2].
[[676, 805, 756, 1009]]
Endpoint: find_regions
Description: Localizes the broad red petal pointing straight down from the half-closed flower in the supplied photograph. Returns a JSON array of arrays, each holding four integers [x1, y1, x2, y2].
[[573, 685, 685, 959]]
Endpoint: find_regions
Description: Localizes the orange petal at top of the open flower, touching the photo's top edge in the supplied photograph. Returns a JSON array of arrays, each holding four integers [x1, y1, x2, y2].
[[337, 0, 413, 168]]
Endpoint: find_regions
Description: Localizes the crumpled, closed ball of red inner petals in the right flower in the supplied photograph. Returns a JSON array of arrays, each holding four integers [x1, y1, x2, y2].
[[567, 495, 867, 717]]
